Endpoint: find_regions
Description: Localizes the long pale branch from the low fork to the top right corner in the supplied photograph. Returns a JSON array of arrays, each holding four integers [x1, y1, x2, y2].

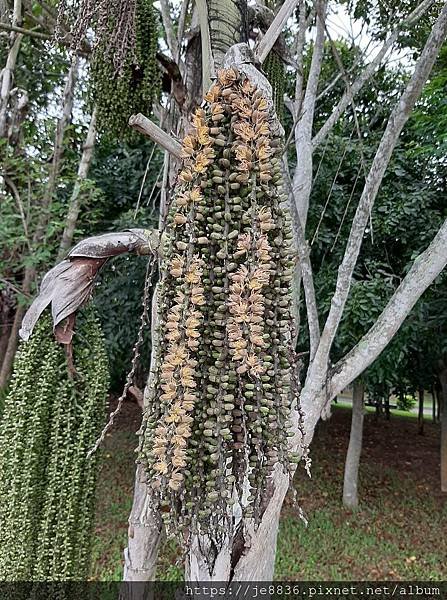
[[308, 4, 447, 378]]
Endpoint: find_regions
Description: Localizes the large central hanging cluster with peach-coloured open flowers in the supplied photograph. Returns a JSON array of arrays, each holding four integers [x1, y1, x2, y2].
[[139, 68, 297, 543]]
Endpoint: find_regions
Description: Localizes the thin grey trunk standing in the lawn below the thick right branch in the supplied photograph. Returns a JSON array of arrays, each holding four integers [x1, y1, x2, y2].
[[343, 379, 365, 510]]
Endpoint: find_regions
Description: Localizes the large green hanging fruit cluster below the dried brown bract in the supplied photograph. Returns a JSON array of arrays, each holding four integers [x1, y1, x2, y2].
[[0, 311, 108, 581]]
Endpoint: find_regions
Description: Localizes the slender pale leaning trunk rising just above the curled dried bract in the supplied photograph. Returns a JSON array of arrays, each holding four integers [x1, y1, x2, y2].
[[57, 110, 96, 261]]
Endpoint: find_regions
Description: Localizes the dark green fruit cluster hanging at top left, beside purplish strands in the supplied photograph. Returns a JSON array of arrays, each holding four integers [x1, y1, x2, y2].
[[82, 0, 160, 139]]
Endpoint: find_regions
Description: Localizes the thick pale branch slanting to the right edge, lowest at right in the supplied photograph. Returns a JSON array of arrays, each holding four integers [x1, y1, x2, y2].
[[328, 220, 447, 401]]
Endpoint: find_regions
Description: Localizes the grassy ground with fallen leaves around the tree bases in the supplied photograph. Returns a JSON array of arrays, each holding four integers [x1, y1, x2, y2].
[[91, 405, 447, 580]]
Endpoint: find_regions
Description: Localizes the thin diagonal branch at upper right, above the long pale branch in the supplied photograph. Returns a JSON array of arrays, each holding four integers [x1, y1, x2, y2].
[[312, 0, 440, 149]]
